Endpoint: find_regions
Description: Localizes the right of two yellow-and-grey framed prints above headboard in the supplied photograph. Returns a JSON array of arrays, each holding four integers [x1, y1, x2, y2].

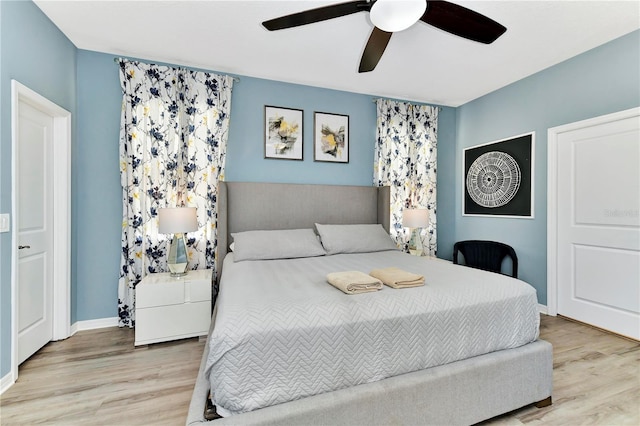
[[313, 112, 349, 163]]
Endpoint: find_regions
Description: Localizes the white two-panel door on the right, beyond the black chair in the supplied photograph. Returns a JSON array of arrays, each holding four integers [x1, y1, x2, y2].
[[556, 113, 640, 339]]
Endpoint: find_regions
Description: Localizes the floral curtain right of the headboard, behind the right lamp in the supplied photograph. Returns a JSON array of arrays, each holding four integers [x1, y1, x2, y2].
[[373, 99, 438, 255]]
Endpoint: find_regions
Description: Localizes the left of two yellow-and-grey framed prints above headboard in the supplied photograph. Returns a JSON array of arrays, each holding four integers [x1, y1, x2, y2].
[[264, 105, 303, 160]]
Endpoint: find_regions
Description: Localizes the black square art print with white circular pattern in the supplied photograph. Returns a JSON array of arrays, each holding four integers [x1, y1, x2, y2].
[[462, 132, 534, 218]]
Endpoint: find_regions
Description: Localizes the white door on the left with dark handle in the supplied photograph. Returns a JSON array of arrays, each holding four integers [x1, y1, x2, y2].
[[16, 102, 53, 364]]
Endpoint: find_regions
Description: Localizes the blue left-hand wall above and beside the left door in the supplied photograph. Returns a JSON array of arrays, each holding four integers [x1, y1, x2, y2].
[[0, 1, 77, 377]]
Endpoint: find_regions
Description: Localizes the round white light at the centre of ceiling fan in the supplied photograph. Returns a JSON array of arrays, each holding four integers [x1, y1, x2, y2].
[[369, 0, 427, 33]]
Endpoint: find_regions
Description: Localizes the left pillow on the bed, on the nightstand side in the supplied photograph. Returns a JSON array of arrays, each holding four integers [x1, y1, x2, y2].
[[231, 229, 326, 262]]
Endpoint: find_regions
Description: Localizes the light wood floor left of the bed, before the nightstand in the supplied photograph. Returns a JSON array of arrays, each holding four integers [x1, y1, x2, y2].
[[0, 328, 204, 425]]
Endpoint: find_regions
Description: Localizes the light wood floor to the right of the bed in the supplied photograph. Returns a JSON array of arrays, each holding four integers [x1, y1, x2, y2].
[[485, 315, 640, 426]]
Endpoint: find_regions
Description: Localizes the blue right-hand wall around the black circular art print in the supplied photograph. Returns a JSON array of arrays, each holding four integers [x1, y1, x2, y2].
[[452, 31, 640, 304]]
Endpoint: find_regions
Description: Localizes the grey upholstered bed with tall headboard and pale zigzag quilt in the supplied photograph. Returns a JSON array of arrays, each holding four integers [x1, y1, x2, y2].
[[187, 182, 552, 425]]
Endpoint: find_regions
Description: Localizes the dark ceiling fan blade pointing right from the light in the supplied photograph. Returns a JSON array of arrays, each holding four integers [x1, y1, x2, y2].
[[420, 0, 507, 44]]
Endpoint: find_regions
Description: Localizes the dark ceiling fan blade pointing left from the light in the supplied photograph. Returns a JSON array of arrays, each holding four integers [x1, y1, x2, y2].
[[262, 0, 373, 31]]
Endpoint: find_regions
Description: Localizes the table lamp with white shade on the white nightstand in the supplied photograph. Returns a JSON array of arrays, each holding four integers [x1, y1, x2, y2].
[[158, 207, 198, 277]]
